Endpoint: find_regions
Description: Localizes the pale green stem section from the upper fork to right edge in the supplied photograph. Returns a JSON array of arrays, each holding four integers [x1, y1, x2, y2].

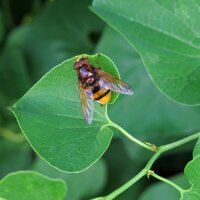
[[162, 132, 200, 152]]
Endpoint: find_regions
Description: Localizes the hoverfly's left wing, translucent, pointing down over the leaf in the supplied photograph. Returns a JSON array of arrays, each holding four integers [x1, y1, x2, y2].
[[78, 81, 93, 124]]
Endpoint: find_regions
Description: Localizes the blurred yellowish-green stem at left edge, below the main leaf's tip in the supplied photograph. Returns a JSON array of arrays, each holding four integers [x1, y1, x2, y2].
[[0, 128, 25, 143]]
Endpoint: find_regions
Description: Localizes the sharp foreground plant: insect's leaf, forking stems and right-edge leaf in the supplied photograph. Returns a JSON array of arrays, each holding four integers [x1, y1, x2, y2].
[[10, 54, 200, 199]]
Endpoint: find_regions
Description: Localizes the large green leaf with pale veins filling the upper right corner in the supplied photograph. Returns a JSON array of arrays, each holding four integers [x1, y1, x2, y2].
[[91, 0, 200, 105]]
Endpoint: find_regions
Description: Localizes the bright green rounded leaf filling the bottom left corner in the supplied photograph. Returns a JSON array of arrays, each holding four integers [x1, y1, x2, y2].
[[0, 171, 66, 200]]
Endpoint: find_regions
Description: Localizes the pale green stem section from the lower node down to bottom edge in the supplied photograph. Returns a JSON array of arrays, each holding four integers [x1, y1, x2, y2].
[[103, 170, 146, 200]]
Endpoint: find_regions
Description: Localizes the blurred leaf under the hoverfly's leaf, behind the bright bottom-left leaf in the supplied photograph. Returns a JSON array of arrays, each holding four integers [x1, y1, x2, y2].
[[33, 159, 107, 200]]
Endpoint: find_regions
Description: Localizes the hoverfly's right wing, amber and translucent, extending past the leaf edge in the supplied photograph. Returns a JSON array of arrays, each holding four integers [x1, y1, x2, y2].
[[96, 69, 133, 95]]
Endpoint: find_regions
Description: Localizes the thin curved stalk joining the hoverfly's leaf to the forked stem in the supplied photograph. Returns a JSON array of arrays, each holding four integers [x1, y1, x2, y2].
[[109, 122, 157, 152]]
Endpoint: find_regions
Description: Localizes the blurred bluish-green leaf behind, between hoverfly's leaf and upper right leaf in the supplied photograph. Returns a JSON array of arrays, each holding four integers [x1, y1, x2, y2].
[[96, 25, 200, 162]]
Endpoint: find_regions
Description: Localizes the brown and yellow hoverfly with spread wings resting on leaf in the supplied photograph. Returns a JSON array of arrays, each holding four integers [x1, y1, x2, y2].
[[74, 58, 133, 124]]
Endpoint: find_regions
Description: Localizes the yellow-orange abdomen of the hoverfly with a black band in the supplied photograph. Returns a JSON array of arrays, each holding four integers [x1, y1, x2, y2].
[[93, 88, 111, 104]]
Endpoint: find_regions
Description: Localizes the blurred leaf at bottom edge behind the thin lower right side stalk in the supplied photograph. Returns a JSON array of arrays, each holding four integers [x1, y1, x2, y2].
[[138, 174, 189, 200]]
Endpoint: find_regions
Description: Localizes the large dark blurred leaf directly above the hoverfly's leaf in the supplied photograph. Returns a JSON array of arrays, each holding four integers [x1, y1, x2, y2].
[[23, 0, 104, 82]]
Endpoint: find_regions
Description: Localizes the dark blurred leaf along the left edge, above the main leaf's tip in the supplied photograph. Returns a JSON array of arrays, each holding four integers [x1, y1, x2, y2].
[[0, 29, 30, 125]]
